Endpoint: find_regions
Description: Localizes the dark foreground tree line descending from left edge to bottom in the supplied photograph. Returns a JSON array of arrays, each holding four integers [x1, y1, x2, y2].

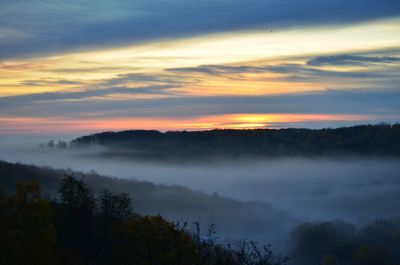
[[0, 176, 287, 265]]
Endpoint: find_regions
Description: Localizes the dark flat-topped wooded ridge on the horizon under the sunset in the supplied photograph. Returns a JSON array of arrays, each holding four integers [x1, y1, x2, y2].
[[70, 124, 400, 159]]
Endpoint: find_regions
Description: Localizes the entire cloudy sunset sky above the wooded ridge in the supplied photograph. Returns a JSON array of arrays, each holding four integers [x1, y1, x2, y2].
[[0, 0, 400, 136]]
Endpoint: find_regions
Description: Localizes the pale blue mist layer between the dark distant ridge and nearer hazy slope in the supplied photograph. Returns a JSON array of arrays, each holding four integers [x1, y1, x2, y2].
[[0, 136, 400, 225]]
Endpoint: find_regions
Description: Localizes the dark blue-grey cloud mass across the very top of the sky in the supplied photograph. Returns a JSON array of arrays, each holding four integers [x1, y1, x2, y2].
[[0, 0, 400, 59]]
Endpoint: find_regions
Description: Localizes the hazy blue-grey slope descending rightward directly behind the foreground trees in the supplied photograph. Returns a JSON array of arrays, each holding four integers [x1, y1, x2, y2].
[[0, 161, 293, 244]]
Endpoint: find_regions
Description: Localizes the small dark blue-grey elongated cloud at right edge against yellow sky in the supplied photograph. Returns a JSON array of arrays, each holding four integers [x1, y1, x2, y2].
[[307, 55, 400, 66]]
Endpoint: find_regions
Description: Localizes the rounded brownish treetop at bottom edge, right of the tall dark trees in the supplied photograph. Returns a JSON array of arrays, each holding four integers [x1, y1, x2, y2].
[[116, 216, 197, 265]]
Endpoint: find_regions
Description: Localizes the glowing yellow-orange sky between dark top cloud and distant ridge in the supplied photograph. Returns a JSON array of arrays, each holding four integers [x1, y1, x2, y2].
[[0, 0, 400, 133]]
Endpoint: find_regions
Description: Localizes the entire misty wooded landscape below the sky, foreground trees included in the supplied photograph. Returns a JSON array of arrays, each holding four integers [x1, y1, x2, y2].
[[0, 124, 400, 265]]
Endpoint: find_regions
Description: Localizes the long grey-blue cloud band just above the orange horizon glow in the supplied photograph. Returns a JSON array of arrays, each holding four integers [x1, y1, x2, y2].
[[0, 87, 400, 118]]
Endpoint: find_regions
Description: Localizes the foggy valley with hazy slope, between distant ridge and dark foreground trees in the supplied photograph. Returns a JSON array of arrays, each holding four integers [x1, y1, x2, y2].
[[0, 128, 400, 264]]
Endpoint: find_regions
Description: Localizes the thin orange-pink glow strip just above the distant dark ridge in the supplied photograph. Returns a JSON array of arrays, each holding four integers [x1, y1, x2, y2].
[[0, 113, 376, 134]]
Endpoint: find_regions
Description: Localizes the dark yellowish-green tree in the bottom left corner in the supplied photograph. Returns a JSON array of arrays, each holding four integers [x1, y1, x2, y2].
[[0, 182, 56, 265]]
